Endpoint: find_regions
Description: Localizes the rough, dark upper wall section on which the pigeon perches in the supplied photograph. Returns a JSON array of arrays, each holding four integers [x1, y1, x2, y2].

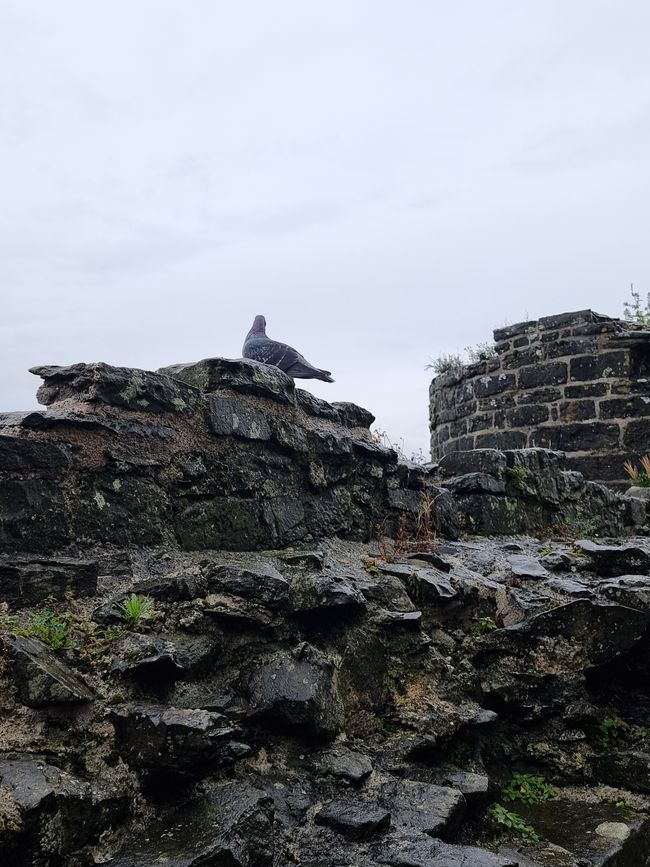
[[0, 359, 451, 553]]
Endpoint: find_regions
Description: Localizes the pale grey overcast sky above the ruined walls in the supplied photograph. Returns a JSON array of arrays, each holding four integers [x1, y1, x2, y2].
[[0, 0, 650, 453]]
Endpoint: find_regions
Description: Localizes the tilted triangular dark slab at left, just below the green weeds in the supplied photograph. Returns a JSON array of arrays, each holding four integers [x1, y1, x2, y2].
[[9, 636, 95, 707]]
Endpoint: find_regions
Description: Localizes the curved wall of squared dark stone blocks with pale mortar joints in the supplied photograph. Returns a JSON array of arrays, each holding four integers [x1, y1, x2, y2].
[[430, 310, 650, 486]]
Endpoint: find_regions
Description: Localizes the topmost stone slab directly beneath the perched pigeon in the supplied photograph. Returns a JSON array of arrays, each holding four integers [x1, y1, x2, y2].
[[158, 358, 296, 405]]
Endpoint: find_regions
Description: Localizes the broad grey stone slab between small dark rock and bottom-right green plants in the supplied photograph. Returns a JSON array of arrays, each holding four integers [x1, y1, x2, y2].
[[379, 780, 467, 838]]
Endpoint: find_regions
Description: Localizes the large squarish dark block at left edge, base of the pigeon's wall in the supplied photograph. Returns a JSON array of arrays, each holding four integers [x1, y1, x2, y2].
[[0, 479, 70, 552]]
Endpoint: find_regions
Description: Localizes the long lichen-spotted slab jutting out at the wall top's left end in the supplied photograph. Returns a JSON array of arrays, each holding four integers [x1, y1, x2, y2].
[[30, 362, 199, 414]]
